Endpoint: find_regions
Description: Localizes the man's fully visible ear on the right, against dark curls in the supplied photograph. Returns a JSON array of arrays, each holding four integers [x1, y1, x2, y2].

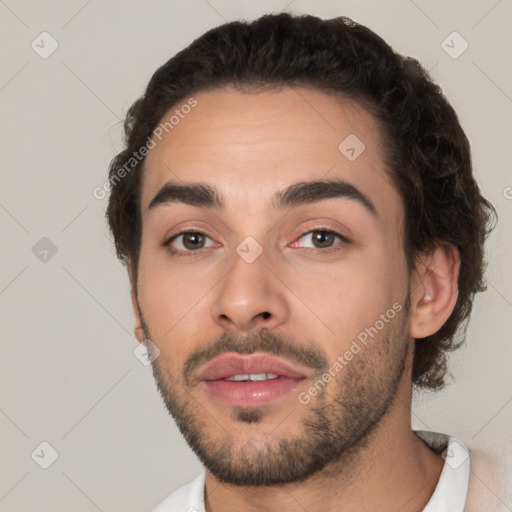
[[410, 242, 460, 338]]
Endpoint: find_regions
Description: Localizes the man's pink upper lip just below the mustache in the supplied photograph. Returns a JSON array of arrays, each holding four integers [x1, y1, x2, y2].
[[198, 353, 307, 380]]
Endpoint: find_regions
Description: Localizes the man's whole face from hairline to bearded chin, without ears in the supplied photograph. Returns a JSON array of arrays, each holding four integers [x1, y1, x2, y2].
[[136, 88, 411, 485]]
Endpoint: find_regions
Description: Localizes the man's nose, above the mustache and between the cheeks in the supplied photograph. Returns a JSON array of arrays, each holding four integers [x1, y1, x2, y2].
[[211, 250, 289, 332]]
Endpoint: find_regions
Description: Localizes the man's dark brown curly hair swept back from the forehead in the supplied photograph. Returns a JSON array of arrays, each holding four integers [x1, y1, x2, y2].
[[107, 13, 496, 389]]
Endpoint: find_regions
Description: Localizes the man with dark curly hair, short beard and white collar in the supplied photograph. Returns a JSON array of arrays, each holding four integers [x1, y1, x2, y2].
[[107, 13, 493, 512]]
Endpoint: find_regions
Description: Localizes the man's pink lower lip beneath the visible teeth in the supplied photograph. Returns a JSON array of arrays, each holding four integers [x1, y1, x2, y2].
[[203, 377, 304, 407]]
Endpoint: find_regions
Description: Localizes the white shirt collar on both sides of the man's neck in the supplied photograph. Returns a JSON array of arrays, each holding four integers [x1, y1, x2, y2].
[[153, 430, 470, 512]]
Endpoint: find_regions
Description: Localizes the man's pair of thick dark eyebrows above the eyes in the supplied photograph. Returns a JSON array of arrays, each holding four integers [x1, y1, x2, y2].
[[148, 180, 378, 217]]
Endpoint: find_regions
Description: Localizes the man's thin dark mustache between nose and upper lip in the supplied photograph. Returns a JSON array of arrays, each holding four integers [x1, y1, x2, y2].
[[183, 328, 329, 383]]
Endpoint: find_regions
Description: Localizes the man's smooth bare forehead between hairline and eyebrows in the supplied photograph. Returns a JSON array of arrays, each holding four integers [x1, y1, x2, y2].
[[141, 87, 401, 222]]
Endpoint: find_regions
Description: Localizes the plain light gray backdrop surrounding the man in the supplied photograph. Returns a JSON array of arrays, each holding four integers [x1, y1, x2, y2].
[[0, 0, 512, 512]]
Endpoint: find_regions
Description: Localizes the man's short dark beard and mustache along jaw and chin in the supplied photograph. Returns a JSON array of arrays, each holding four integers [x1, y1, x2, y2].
[[139, 297, 410, 486]]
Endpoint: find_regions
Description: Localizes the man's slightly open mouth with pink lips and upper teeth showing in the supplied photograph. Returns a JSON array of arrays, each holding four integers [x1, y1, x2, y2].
[[199, 353, 309, 408]]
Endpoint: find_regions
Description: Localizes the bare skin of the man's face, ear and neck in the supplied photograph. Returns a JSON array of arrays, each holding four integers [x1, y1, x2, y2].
[[129, 88, 459, 512]]
